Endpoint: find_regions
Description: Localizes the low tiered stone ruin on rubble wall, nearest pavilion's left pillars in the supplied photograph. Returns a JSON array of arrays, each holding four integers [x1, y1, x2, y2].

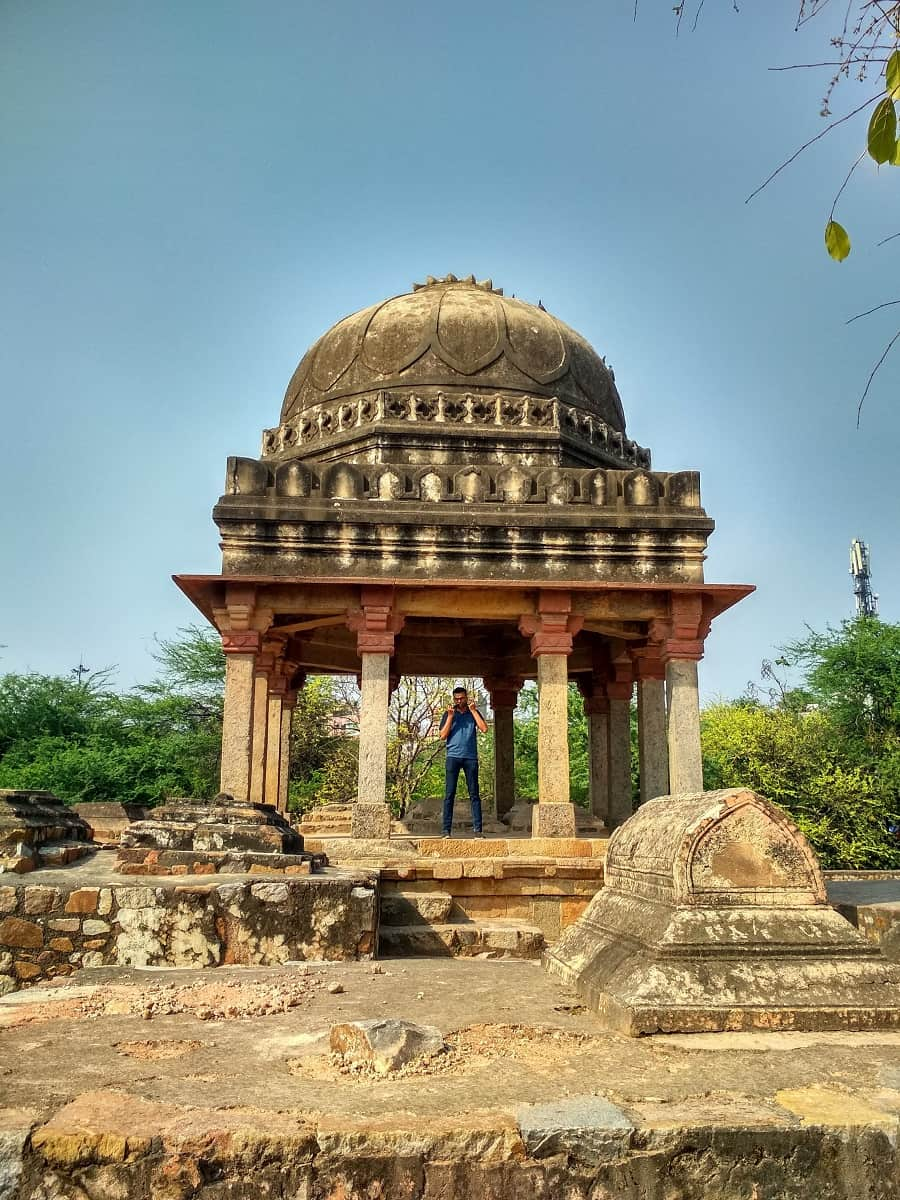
[[116, 792, 325, 875]]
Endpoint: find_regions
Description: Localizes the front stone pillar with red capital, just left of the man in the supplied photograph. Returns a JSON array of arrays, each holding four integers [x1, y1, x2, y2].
[[348, 587, 403, 838]]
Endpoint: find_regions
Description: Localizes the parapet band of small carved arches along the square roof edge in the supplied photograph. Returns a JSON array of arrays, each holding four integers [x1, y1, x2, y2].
[[220, 458, 702, 514]]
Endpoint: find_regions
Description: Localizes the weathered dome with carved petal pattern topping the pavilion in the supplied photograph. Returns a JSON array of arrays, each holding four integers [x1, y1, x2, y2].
[[281, 275, 625, 433]]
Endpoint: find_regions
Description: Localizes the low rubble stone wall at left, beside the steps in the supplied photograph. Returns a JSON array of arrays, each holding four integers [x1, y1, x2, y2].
[[0, 872, 378, 995]]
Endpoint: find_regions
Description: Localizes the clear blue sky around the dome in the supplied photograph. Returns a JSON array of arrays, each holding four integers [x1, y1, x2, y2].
[[0, 0, 900, 697]]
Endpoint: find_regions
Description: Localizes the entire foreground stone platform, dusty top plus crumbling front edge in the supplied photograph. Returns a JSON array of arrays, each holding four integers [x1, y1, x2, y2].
[[0, 960, 900, 1200]]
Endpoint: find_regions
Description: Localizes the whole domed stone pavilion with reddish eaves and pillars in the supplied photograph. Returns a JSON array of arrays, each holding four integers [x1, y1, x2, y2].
[[176, 275, 752, 838]]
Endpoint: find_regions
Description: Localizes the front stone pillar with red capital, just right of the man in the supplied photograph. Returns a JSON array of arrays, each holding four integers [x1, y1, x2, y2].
[[518, 592, 582, 838]]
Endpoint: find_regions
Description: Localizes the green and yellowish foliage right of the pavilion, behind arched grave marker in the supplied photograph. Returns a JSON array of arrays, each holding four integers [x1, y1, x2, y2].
[[702, 617, 900, 868]]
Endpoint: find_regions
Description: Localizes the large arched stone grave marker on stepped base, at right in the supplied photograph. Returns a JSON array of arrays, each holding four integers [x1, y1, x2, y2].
[[544, 790, 900, 1036]]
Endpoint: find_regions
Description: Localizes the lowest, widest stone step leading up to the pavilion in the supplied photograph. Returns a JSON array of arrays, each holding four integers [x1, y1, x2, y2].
[[378, 920, 545, 959]]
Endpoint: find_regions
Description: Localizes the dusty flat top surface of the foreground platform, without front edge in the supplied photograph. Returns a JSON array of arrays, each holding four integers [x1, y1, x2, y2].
[[0, 959, 900, 1124]]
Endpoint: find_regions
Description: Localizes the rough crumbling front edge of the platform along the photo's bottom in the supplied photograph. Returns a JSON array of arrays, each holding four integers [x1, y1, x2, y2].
[[0, 1092, 900, 1200]]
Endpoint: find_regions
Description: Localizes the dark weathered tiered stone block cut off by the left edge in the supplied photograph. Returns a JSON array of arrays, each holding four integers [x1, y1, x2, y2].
[[0, 790, 96, 875]]
